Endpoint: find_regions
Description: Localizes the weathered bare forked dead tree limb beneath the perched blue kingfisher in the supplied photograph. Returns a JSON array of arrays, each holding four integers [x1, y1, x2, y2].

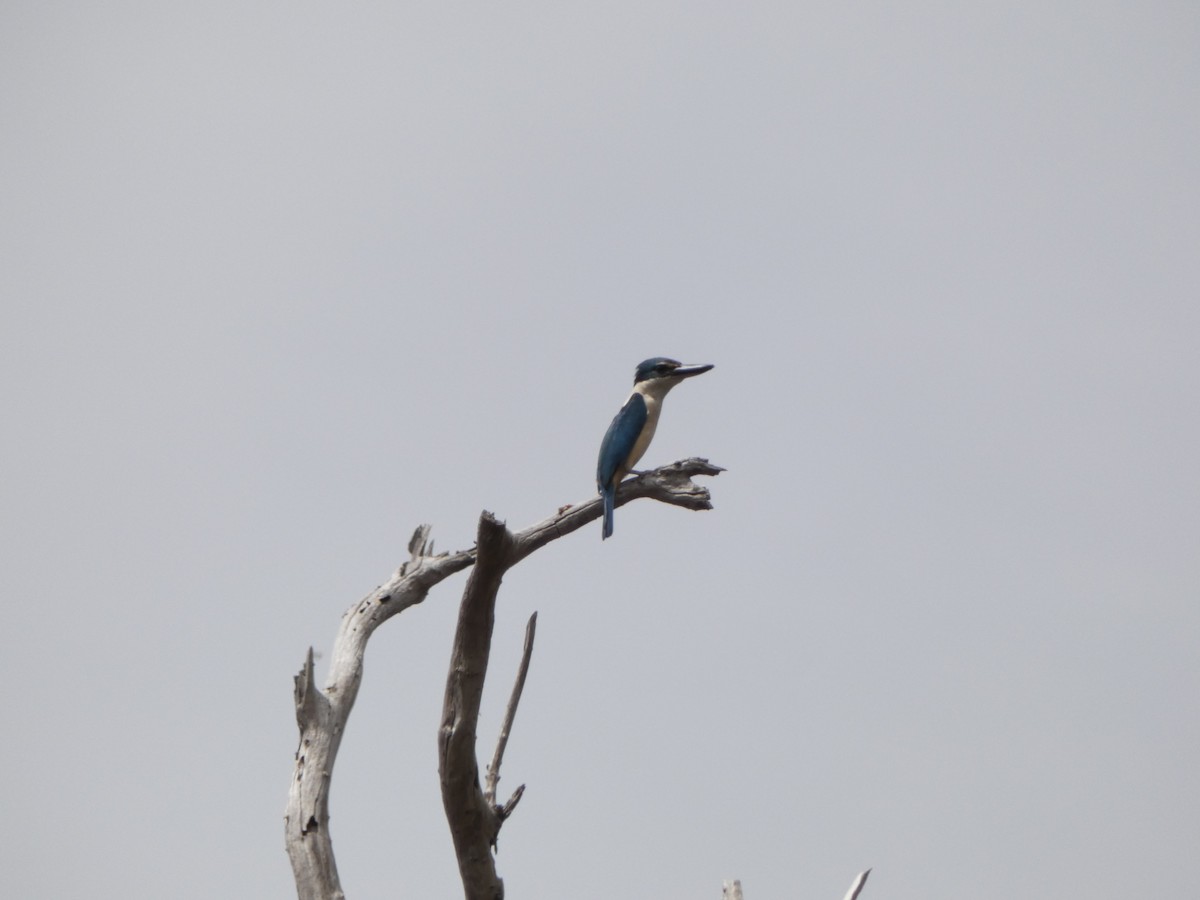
[[284, 457, 724, 900]]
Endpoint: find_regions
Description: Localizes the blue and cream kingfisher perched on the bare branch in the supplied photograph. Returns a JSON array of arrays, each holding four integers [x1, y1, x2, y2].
[[596, 356, 713, 540]]
